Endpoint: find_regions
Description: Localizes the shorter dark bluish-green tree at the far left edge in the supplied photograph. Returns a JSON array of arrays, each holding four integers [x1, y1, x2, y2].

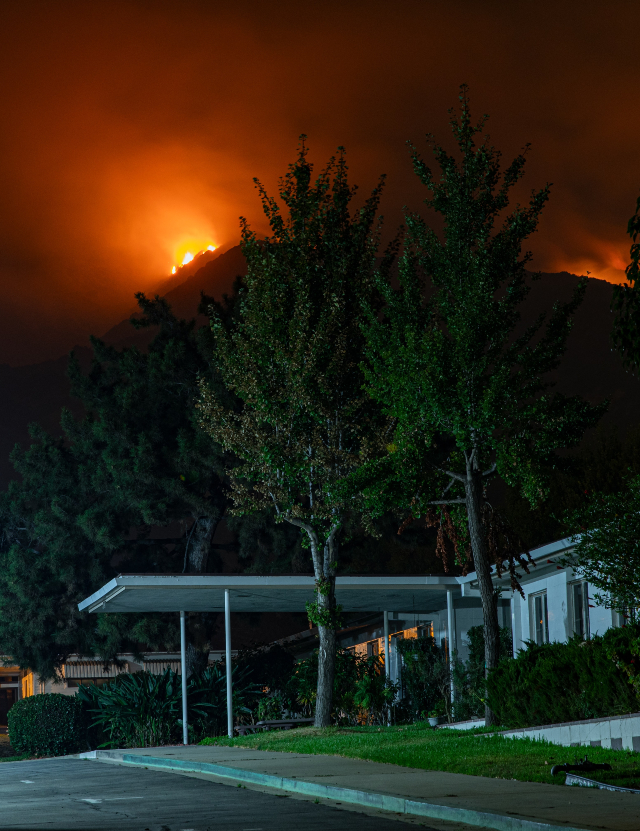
[[0, 427, 130, 678]]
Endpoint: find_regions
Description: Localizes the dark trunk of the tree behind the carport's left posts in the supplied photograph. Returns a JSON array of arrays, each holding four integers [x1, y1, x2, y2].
[[185, 516, 219, 678]]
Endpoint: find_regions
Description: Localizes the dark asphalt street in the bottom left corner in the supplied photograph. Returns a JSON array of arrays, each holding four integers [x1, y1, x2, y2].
[[0, 759, 420, 831]]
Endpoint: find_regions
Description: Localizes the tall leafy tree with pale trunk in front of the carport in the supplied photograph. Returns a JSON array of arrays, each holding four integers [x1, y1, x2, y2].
[[199, 138, 390, 727]]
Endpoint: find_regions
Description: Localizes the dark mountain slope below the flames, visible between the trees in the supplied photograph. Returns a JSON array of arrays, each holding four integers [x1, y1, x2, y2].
[[0, 255, 640, 487]]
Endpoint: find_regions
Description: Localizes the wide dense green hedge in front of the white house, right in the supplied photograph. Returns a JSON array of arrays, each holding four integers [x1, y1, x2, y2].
[[487, 627, 639, 727]]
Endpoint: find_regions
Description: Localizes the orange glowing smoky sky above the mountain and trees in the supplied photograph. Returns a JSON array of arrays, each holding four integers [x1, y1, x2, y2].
[[0, 0, 640, 364]]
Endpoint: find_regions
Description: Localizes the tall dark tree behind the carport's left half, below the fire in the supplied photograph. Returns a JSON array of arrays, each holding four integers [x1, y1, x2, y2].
[[64, 294, 229, 672]]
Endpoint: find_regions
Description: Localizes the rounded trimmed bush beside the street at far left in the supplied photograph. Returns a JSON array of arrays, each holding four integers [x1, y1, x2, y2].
[[8, 693, 88, 756]]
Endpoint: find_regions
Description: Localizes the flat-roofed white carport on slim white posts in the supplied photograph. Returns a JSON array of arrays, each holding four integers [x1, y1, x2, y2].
[[78, 574, 461, 744]]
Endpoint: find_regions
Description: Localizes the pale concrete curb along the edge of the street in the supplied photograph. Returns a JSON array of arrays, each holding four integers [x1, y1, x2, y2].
[[78, 750, 586, 831]]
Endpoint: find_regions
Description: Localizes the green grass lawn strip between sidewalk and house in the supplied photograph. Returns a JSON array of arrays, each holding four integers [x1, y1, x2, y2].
[[201, 724, 640, 788]]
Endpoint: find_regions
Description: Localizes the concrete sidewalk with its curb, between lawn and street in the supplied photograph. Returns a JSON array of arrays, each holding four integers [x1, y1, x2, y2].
[[80, 746, 640, 831]]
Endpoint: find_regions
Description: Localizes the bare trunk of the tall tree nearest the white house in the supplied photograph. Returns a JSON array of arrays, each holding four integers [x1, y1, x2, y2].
[[465, 463, 500, 727]]
